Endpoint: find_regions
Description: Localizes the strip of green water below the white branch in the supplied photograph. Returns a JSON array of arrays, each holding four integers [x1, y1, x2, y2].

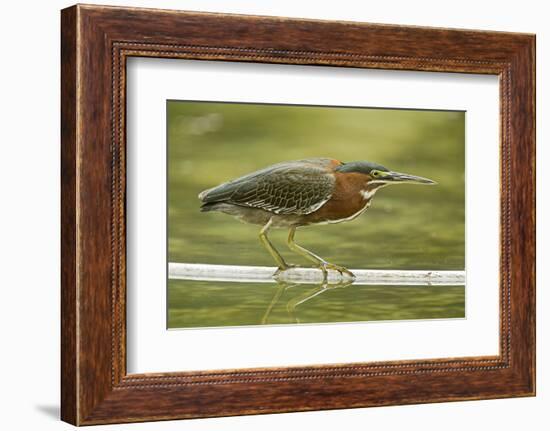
[[168, 281, 464, 328]]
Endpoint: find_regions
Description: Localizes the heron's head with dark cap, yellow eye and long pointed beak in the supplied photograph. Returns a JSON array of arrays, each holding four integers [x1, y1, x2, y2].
[[336, 161, 437, 190]]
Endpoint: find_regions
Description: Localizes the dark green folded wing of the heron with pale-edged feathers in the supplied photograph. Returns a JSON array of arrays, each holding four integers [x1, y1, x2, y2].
[[199, 160, 335, 214]]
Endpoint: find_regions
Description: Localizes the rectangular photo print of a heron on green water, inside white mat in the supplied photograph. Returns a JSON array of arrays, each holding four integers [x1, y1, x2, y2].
[[167, 100, 465, 329]]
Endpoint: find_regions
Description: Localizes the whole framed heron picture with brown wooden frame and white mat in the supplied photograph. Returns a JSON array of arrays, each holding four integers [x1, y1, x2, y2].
[[61, 5, 535, 425]]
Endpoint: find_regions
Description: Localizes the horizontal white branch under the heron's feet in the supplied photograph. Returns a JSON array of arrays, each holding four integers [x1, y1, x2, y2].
[[168, 262, 466, 286]]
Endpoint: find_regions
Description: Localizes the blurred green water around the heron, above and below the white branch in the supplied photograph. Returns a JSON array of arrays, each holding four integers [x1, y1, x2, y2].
[[167, 101, 465, 328]]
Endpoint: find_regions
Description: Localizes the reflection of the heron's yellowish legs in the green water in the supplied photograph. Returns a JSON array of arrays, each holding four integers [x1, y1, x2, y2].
[[261, 279, 353, 325]]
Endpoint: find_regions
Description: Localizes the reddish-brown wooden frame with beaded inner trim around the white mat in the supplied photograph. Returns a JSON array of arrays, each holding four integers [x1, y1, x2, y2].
[[61, 5, 535, 425]]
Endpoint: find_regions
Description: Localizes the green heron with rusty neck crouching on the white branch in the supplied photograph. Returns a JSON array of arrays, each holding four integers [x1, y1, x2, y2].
[[199, 158, 436, 281]]
